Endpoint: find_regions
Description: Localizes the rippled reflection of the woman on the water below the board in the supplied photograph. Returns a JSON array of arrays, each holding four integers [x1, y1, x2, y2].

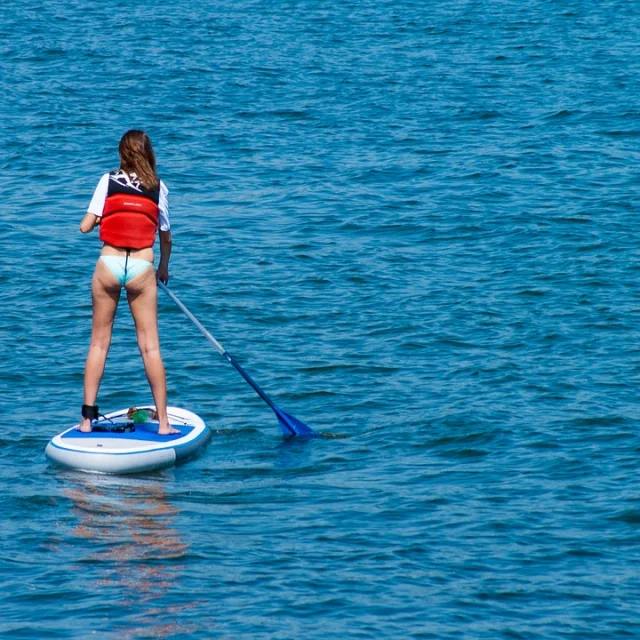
[[65, 474, 195, 638]]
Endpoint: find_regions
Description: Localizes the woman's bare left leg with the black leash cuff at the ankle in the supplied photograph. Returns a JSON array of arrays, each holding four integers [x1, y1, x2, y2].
[[80, 260, 120, 431]]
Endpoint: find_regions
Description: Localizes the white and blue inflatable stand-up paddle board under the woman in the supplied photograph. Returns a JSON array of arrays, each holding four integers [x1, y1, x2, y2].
[[45, 406, 211, 473]]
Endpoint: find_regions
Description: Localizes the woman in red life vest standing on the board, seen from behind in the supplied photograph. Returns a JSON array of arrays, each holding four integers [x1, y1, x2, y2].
[[80, 130, 179, 435]]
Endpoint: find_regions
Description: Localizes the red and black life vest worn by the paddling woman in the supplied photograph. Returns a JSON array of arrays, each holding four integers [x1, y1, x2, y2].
[[100, 170, 160, 249]]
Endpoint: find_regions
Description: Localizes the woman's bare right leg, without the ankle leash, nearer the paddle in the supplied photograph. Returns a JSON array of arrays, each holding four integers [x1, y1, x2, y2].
[[126, 268, 179, 435]]
